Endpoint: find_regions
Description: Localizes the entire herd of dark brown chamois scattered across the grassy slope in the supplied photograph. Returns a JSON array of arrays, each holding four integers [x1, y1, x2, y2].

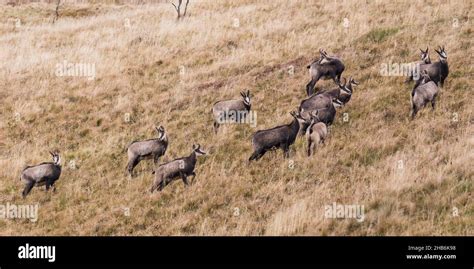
[[20, 47, 449, 197]]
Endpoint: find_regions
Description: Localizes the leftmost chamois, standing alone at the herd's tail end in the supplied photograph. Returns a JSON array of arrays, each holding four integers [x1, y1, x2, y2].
[[20, 152, 61, 198]]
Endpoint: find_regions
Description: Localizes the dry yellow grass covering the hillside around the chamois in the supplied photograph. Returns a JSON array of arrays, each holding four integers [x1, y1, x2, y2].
[[0, 0, 474, 235]]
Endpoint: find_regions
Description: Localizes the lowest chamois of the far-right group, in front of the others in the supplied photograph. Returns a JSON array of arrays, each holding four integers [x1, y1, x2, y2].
[[411, 70, 439, 118]]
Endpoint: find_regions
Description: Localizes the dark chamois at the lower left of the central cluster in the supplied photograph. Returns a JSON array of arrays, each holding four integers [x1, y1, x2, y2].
[[249, 109, 304, 162]]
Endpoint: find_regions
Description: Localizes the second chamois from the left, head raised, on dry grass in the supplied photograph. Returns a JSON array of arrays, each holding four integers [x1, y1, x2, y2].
[[127, 126, 168, 176]]
